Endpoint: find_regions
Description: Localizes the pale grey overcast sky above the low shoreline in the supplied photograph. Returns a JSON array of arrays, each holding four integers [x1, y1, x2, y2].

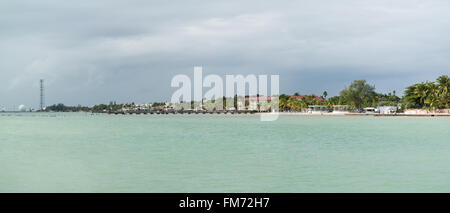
[[0, 0, 450, 109]]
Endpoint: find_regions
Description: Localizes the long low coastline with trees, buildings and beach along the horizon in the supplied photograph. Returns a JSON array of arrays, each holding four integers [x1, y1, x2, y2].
[[10, 75, 450, 116]]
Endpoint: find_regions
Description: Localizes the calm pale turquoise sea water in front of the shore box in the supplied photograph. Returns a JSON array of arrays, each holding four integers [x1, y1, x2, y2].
[[0, 113, 450, 192]]
